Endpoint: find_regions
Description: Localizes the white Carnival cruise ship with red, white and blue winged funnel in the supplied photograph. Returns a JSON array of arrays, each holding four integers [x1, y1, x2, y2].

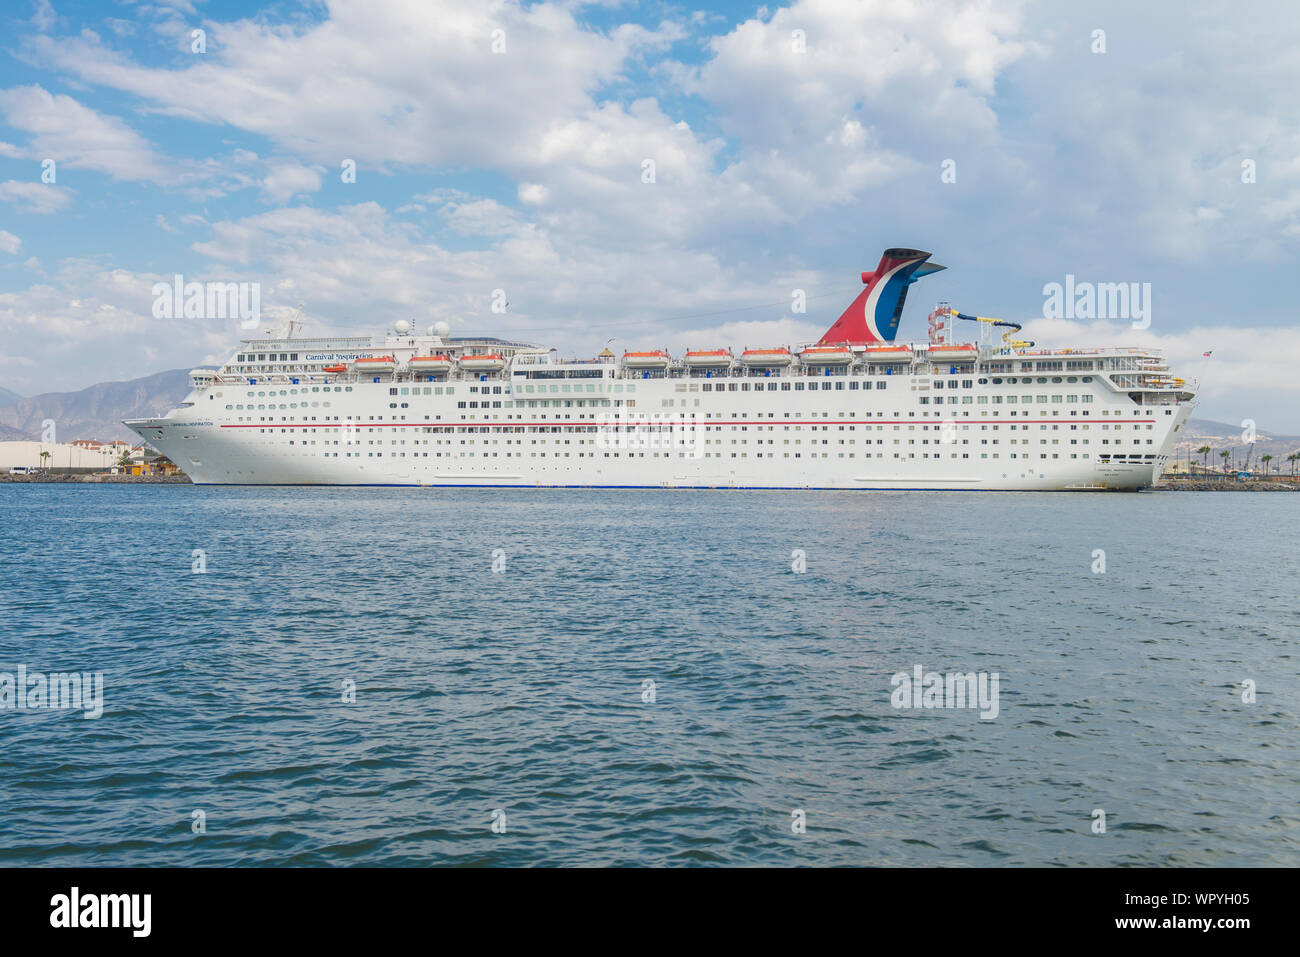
[[125, 248, 1195, 490]]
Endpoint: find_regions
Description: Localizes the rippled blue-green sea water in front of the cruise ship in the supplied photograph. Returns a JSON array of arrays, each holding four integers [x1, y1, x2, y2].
[[0, 485, 1300, 866]]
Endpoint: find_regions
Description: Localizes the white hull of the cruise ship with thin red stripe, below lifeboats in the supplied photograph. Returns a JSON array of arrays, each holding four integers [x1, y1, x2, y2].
[[129, 369, 1192, 490]]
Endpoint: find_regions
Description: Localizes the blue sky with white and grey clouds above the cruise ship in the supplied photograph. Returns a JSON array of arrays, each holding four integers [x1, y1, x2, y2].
[[0, 0, 1300, 432]]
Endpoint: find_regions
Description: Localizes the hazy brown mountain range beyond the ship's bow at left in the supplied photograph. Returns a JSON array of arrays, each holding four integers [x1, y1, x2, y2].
[[0, 369, 191, 442]]
